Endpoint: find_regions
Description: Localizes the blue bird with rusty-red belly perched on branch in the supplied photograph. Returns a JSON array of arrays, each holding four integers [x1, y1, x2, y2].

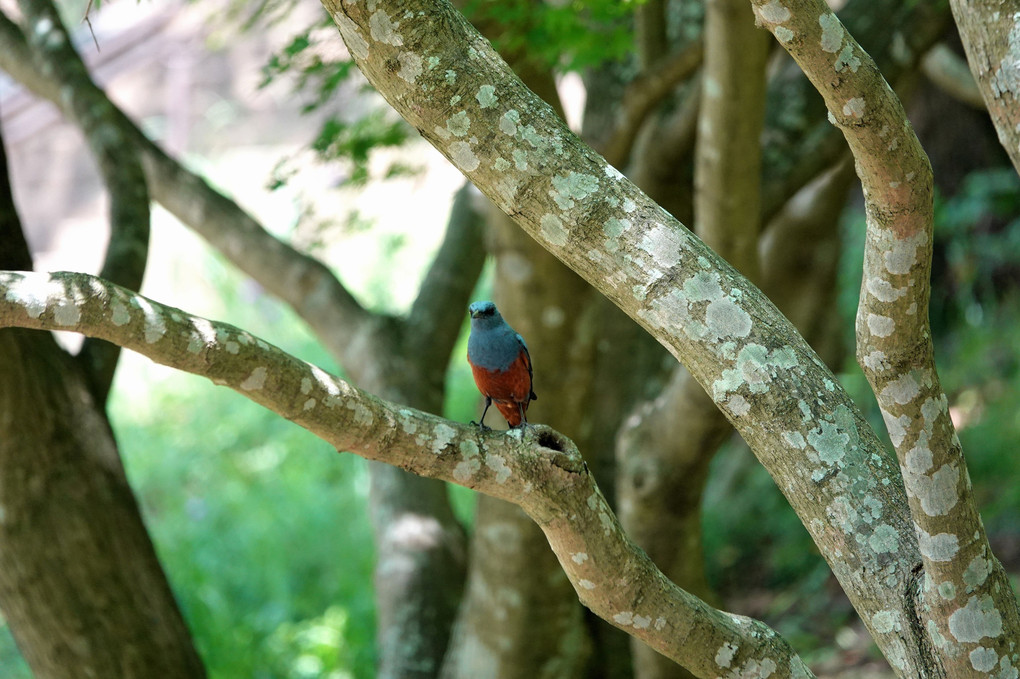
[[467, 302, 539, 429]]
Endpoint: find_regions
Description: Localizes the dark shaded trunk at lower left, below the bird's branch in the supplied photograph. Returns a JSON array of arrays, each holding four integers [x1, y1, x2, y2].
[[0, 329, 205, 679]]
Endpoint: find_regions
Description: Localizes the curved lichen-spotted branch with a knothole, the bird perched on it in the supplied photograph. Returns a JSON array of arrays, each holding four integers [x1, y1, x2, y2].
[[0, 272, 813, 678]]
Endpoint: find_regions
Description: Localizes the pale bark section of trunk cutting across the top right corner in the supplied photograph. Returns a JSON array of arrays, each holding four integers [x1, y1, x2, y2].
[[950, 0, 1020, 171]]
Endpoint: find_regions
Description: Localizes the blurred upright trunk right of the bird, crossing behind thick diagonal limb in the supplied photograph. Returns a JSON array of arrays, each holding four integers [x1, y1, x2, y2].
[[618, 0, 771, 679]]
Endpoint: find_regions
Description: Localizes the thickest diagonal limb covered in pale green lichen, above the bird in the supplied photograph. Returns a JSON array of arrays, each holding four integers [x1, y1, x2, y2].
[[316, 0, 1011, 668]]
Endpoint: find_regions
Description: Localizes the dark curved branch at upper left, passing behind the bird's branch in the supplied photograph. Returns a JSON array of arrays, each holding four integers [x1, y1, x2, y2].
[[20, 0, 149, 403]]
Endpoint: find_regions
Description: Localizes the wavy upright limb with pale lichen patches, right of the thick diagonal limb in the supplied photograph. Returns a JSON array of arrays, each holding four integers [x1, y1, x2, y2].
[[753, 0, 1020, 677]]
